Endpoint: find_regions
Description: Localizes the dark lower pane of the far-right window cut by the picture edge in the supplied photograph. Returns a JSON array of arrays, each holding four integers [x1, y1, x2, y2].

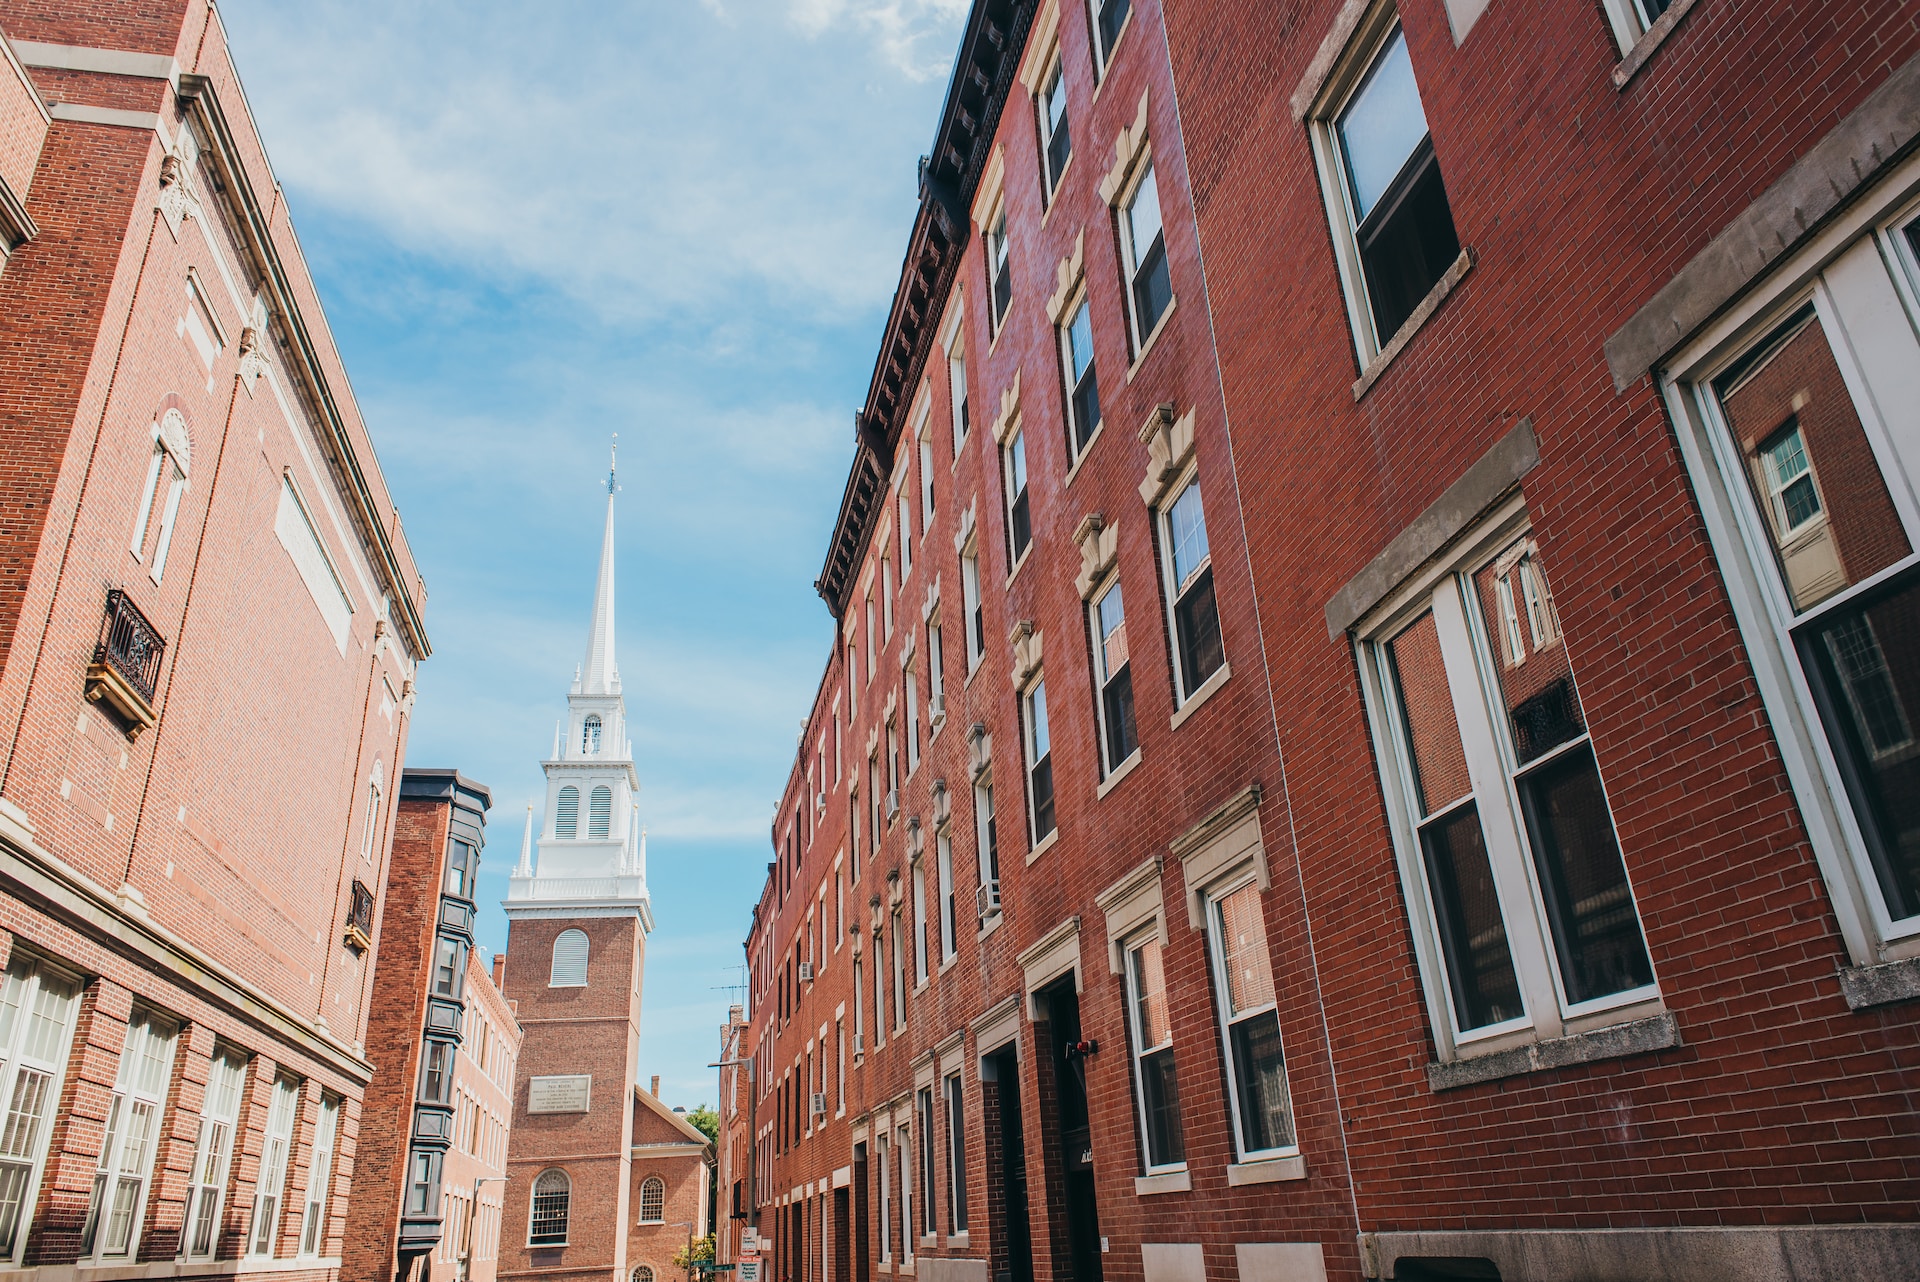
[[1795, 574, 1920, 919]]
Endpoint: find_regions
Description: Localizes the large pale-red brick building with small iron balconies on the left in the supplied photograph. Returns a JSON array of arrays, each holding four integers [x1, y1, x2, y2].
[[0, 0, 428, 1278]]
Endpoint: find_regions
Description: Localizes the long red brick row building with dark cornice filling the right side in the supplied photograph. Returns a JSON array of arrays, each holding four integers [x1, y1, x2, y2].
[[722, 0, 1920, 1282]]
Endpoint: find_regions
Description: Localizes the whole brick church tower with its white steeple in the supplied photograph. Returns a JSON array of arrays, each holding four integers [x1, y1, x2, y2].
[[499, 452, 653, 1282]]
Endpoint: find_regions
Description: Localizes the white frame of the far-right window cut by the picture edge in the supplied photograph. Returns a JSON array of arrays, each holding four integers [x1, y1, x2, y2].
[[1657, 159, 1920, 965]]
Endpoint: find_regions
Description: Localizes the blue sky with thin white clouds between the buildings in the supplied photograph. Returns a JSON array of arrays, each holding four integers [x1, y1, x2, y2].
[[223, 0, 966, 1107]]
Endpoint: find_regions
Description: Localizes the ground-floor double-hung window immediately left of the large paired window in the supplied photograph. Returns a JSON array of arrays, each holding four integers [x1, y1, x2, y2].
[[1206, 873, 1298, 1161]]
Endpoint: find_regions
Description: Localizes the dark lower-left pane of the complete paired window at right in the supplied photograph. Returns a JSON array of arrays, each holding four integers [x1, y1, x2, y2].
[[1421, 804, 1526, 1033]]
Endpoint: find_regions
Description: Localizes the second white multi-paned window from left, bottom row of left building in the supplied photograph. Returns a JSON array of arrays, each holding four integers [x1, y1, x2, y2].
[[81, 1011, 175, 1259]]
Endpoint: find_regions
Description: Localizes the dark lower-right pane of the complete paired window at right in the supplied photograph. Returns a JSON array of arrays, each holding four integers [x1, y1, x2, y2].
[[1519, 745, 1653, 1002]]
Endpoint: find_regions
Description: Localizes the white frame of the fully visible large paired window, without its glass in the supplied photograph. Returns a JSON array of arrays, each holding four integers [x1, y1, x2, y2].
[[1356, 493, 1663, 1061]]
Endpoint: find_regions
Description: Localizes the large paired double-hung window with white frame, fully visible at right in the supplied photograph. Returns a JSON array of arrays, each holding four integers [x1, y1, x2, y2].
[[1363, 514, 1659, 1057]]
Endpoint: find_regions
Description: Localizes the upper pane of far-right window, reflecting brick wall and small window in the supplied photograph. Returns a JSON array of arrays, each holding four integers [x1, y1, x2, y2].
[[1715, 307, 1912, 610]]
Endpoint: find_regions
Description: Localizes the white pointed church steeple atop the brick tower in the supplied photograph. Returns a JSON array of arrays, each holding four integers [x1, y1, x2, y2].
[[505, 443, 653, 931]]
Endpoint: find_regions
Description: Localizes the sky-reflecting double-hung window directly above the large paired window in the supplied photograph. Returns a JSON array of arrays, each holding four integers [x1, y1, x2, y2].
[[1315, 21, 1459, 365]]
